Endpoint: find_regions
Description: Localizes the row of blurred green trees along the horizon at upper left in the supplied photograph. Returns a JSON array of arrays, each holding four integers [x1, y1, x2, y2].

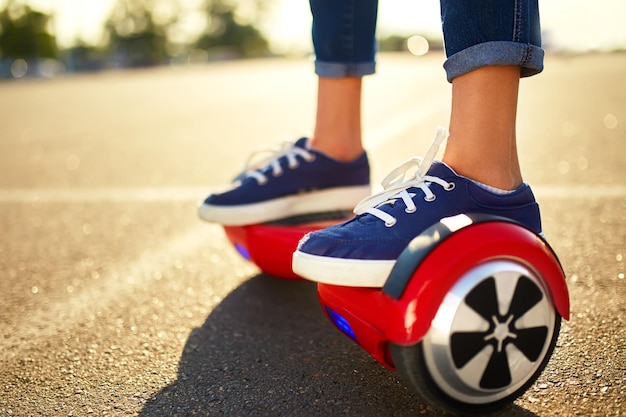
[[0, 0, 271, 71]]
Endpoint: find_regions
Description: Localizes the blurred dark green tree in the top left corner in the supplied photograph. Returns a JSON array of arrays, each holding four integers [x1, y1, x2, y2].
[[0, 0, 57, 61]]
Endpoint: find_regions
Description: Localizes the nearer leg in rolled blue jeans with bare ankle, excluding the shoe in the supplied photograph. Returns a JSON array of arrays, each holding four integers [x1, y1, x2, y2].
[[441, 0, 543, 190]]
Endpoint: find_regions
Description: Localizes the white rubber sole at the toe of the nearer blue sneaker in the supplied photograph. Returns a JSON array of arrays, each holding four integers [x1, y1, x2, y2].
[[292, 251, 396, 288]]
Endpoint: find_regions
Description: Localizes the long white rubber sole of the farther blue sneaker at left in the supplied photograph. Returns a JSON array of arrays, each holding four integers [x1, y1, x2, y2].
[[198, 185, 370, 226]]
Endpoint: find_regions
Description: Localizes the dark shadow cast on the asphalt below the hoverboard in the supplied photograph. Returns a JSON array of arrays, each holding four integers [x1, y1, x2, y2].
[[140, 275, 534, 416]]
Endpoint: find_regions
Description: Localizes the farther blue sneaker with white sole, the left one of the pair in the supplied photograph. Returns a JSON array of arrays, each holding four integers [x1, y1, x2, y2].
[[198, 138, 370, 226]]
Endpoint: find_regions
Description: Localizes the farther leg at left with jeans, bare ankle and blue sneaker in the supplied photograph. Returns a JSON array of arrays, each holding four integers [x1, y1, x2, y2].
[[198, 0, 378, 226]]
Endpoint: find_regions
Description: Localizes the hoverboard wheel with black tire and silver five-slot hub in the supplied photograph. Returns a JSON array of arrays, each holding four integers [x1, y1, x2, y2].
[[390, 260, 561, 414]]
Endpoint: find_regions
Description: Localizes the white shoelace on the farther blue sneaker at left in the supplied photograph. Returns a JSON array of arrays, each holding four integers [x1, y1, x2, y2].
[[244, 142, 315, 185]]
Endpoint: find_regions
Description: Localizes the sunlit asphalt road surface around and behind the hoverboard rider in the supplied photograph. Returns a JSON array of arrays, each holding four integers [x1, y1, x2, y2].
[[0, 54, 626, 417]]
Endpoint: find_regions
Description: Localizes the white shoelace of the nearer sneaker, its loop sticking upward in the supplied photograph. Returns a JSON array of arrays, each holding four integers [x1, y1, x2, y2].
[[354, 127, 454, 227]]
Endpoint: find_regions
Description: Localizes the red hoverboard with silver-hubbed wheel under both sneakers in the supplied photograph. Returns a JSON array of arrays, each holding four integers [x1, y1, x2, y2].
[[225, 213, 569, 412]]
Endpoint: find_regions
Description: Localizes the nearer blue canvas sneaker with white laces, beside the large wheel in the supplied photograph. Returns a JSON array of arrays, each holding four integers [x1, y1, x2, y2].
[[292, 131, 541, 287]]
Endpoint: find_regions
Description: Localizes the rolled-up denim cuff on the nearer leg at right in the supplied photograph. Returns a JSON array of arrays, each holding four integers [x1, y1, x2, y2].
[[443, 41, 544, 82]]
